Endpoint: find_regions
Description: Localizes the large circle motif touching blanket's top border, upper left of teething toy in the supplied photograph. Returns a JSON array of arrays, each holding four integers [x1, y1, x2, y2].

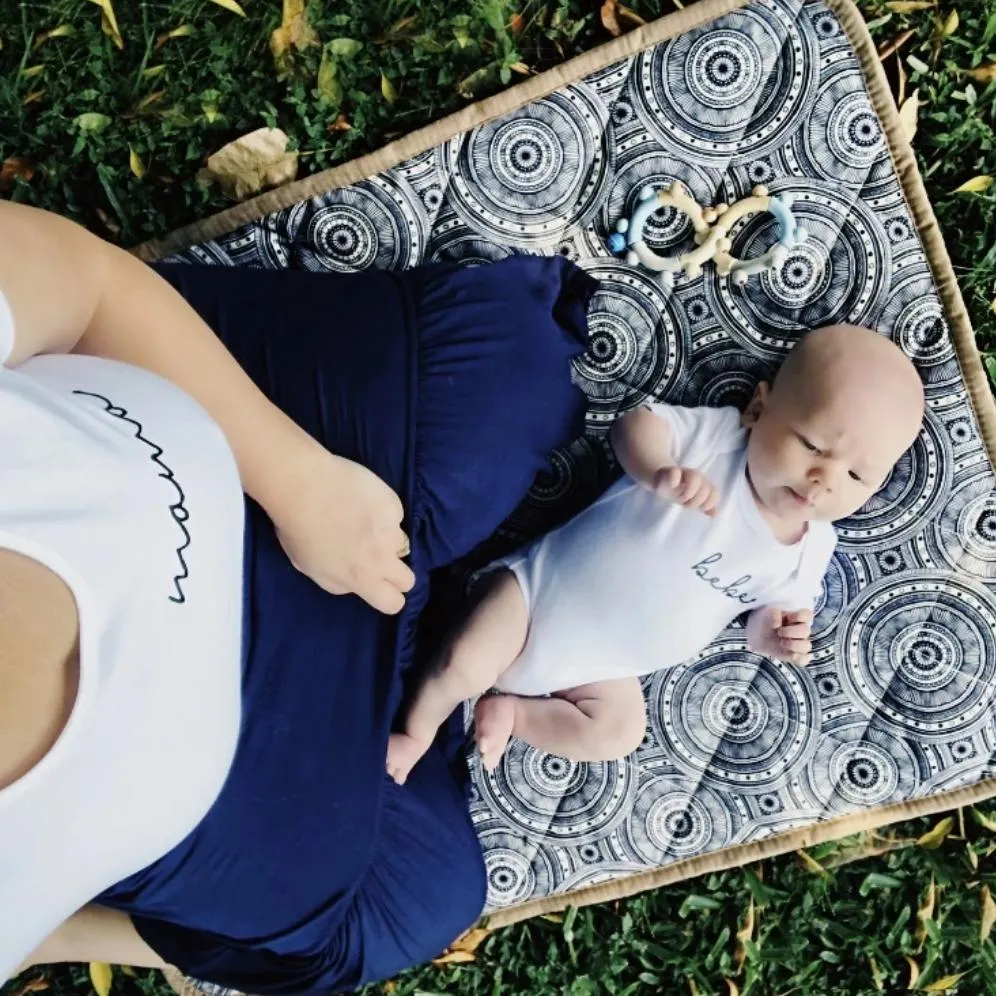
[[443, 84, 610, 249]]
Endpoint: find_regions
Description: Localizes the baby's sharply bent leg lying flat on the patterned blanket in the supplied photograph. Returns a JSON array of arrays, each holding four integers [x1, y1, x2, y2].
[[476, 678, 647, 771]]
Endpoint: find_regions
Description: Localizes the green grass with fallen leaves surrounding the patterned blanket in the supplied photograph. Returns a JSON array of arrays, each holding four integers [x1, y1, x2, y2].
[[0, 0, 996, 996]]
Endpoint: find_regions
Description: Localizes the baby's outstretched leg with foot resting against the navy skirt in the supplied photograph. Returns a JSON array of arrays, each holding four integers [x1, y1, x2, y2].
[[387, 570, 529, 785]]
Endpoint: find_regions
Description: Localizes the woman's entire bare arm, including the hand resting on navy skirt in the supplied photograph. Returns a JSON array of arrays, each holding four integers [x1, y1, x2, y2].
[[0, 202, 415, 612]]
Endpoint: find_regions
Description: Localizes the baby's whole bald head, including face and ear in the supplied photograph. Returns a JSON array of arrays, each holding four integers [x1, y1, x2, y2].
[[743, 325, 924, 524]]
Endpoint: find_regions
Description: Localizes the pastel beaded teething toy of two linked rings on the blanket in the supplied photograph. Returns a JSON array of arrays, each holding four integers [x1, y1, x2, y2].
[[607, 180, 806, 287]]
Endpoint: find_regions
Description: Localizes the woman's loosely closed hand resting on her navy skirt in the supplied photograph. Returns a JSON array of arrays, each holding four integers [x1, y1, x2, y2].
[[266, 440, 415, 615]]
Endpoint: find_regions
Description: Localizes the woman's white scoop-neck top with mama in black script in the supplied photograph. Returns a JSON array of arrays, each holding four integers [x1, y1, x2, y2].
[[0, 294, 244, 982]]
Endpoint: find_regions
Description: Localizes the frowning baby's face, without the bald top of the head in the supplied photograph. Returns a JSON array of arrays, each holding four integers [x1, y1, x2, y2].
[[747, 372, 909, 526]]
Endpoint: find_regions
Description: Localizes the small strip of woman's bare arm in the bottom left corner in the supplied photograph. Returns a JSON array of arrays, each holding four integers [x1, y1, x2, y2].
[[13, 905, 166, 981]]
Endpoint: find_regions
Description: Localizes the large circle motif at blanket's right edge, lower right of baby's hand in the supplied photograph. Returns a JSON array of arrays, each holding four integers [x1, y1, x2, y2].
[[837, 572, 996, 742]]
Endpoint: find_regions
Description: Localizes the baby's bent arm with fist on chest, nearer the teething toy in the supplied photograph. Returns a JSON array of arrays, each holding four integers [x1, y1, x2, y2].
[[609, 407, 719, 515]]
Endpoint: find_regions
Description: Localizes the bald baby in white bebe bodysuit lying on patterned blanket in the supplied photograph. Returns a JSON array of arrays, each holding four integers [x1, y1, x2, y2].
[[387, 325, 924, 783]]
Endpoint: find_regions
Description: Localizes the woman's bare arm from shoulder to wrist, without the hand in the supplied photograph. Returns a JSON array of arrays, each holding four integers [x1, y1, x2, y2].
[[0, 202, 318, 514]]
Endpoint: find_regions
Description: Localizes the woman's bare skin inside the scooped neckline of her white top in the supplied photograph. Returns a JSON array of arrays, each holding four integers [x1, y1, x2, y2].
[[0, 550, 79, 789]]
